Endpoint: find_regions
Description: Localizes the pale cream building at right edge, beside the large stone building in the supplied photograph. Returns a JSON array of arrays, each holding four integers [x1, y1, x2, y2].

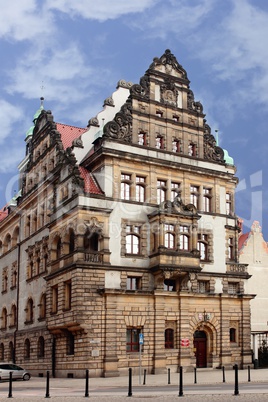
[[239, 221, 268, 364]]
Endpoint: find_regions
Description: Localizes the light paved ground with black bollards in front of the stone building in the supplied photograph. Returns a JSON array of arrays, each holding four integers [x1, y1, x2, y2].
[[0, 369, 268, 402]]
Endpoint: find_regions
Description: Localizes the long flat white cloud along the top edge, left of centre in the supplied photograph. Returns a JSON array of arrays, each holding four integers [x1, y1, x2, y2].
[[46, 0, 156, 22]]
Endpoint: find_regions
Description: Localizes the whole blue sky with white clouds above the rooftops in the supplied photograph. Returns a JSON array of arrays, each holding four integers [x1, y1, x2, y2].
[[0, 0, 268, 240]]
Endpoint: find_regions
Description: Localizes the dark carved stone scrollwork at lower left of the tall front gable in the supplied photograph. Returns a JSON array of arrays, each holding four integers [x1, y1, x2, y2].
[[103, 99, 132, 143]]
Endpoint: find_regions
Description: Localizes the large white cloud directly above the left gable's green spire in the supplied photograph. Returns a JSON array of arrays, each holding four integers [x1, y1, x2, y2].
[[6, 42, 102, 104]]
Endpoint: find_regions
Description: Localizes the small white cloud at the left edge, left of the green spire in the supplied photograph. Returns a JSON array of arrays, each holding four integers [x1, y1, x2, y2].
[[0, 99, 23, 144]]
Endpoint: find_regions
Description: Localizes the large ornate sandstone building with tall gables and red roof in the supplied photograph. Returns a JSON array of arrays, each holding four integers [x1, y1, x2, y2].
[[0, 50, 252, 377]]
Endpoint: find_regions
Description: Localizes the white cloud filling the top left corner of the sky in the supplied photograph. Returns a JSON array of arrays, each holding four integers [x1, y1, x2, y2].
[[0, 0, 53, 41]]
